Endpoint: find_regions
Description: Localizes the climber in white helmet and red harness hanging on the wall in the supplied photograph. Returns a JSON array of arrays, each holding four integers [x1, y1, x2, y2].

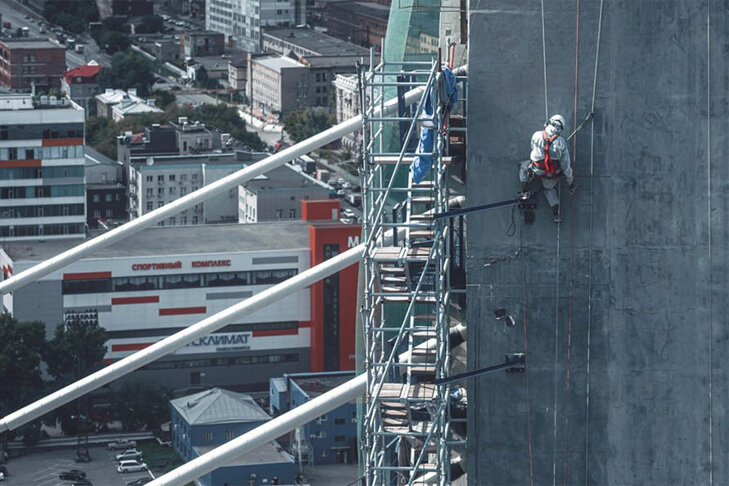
[[519, 114, 576, 223]]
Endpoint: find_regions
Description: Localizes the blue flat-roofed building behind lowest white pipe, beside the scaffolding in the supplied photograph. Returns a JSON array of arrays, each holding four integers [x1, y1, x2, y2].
[[269, 371, 357, 465]]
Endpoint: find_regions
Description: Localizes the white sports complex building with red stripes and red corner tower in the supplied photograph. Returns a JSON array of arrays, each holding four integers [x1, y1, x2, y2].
[[0, 200, 360, 388]]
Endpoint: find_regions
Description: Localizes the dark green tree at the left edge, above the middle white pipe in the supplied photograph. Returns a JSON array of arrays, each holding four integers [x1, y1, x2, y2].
[[0, 312, 46, 416]]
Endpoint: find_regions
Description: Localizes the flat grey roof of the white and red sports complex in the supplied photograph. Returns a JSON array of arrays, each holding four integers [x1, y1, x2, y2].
[[2, 221, 309, 262]]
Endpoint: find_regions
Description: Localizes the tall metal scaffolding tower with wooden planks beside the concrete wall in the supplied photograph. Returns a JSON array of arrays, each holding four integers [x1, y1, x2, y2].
[[359, 52, 466, 485]]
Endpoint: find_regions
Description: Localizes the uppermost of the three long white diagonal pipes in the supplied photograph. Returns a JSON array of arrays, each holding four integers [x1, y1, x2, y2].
[[0, 66, 467, 296]]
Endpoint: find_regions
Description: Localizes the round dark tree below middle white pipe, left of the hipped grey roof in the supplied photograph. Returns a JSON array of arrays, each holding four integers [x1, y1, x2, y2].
[[111, 381, 172, 430]]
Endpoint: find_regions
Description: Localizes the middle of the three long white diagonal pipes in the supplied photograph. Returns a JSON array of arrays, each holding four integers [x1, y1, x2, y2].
[[0, 247, 365, 433]]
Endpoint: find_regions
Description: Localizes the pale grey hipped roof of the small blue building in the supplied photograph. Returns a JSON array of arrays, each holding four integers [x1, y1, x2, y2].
[[170, 388, 271, 425]]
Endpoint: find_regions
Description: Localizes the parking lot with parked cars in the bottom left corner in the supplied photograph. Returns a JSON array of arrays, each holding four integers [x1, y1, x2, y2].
[[4, 446, 152, 486]]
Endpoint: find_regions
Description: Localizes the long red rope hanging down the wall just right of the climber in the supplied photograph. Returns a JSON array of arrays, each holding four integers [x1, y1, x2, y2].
[[562, 0, 587, 486]]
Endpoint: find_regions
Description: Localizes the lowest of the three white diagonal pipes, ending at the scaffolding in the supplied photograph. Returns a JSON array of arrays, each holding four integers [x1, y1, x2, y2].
[[149, 373, 367, 486]]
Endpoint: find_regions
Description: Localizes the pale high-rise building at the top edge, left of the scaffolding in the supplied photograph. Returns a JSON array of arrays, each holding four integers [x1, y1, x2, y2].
[[205, 0, 306, 52]]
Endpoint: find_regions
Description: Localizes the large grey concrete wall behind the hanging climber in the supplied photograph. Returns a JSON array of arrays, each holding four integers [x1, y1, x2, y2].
[[467, 0, 729, 486]]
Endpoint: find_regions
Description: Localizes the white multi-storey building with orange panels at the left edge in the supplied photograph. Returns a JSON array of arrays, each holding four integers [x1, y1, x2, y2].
[[0, 94, 86, 241]]
